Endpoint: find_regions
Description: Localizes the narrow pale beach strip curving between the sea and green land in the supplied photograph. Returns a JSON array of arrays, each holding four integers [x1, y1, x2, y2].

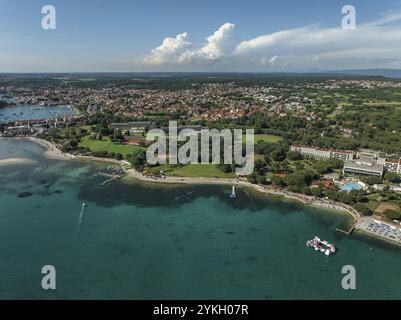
[[22, 137, 361, 224]]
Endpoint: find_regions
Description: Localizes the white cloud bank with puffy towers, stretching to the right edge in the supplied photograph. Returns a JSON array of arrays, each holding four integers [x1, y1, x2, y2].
[[144, 11, 401, 71]]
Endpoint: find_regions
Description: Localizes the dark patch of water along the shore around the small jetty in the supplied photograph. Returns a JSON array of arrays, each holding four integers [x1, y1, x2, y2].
[[78, 177, 310, 213]]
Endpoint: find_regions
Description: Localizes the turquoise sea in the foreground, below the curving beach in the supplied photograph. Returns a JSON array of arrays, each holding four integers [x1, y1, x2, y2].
[[0, 138, 401, 299]]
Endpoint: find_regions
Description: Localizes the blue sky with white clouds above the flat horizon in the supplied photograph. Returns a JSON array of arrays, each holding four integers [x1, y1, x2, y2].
[[0, 0, 401, 72]]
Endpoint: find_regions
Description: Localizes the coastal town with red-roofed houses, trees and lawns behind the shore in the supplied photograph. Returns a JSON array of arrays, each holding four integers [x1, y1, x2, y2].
[[0, 76, 401, 242]]
